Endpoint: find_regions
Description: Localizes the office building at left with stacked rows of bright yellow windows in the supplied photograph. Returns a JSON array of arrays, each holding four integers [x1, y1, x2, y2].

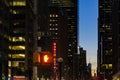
[[5, 0, 34, 77]]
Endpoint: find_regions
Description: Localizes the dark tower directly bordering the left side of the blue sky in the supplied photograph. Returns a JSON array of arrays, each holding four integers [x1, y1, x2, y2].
[[49, 0, 77, 80]]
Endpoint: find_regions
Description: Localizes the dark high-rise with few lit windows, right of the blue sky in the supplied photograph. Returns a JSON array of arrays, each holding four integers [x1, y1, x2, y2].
[[98, 0, 120, 80]]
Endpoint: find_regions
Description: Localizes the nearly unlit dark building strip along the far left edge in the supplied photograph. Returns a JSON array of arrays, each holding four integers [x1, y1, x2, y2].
[[0, 0, 9, 80]]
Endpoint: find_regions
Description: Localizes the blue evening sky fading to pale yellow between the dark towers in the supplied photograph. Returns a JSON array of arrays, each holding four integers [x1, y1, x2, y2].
[[79, 0, 98, 69]]
